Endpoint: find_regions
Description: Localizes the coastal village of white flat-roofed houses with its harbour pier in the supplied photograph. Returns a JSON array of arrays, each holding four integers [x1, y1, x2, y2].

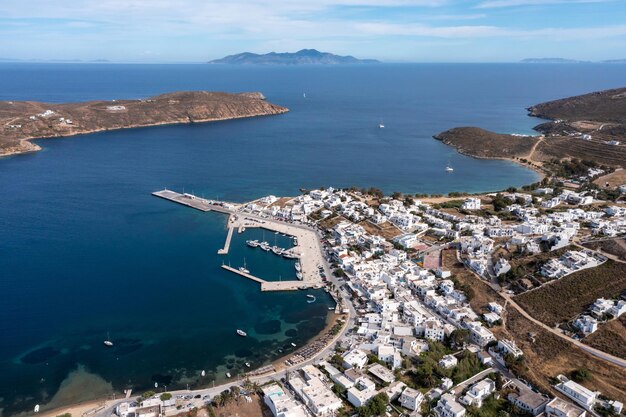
[[92, 161, 626, 417]]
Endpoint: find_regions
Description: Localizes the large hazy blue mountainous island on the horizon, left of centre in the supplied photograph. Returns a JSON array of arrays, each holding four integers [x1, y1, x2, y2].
[[209, 49, 380, 65]]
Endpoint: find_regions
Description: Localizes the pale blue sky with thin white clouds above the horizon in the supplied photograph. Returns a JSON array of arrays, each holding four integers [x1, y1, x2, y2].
[[0, 0, 626, 63]]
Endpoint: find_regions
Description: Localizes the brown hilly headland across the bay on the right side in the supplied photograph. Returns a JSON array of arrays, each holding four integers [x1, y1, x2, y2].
[[434, 88, 626, 171]]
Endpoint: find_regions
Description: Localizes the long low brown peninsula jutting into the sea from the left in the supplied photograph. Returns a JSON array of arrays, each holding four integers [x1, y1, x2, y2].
[[0, 91, 288, 156]]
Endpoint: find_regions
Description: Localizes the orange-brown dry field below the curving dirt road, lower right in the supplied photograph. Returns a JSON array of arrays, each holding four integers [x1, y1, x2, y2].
[[505, 307, 626, 402]]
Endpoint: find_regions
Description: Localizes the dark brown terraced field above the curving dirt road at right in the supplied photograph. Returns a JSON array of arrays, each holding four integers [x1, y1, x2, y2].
[[515, 260, 626, 326]]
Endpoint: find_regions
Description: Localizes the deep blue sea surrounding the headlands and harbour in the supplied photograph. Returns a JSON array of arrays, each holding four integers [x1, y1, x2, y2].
[[0, 64, 626, 415]]
